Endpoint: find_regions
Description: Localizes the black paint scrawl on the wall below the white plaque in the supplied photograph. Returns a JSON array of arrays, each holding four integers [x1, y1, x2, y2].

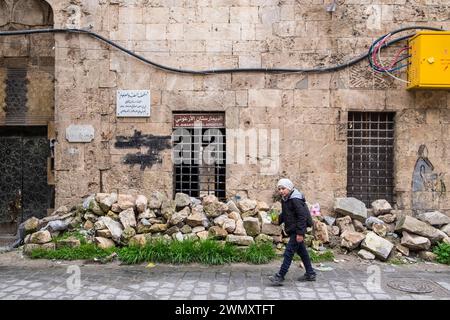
[[114, 130, 171, 170]]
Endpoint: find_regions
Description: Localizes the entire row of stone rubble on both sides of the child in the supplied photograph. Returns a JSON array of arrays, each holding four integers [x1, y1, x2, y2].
[[19, 192, 450, 261]]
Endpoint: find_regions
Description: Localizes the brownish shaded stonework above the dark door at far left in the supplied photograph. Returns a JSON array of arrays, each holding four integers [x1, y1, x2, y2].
[[0, 0, 55, 126]]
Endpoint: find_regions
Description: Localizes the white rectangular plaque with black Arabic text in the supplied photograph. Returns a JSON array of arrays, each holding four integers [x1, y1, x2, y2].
[[117, 90, 150, 117]]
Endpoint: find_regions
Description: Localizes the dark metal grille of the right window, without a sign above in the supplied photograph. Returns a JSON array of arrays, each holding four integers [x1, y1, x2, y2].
[[347, 112, 395, 207]]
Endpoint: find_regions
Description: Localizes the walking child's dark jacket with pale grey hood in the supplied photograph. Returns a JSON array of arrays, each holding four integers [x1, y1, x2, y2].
[[279, 189, 312, 235]]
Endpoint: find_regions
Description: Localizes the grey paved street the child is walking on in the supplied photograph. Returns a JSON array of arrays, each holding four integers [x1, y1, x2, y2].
[[0, 251, 450, 300]]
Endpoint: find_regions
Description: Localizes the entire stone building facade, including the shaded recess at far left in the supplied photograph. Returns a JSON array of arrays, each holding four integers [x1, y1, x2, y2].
[[0, 0, 450, 228]]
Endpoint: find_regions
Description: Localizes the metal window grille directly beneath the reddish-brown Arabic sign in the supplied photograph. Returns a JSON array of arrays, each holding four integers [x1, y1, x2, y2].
[[173, 114, 226, 200]]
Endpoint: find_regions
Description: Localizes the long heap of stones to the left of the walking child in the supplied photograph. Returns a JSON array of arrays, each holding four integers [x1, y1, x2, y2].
[[20, 192, 283, 252]]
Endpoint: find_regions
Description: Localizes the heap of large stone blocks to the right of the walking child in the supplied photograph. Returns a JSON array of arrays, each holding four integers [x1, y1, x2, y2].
[[314, 198, 450, 261]]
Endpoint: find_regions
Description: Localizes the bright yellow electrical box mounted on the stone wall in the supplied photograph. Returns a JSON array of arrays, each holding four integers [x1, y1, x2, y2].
[[407, 31, 450, 89]]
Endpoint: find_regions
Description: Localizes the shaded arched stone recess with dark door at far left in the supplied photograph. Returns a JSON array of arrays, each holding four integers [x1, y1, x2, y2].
[[0, 0, 55, 246]]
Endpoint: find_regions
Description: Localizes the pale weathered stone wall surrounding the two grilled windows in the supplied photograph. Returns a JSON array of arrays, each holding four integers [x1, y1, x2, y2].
[[39, 0, 450, 213]]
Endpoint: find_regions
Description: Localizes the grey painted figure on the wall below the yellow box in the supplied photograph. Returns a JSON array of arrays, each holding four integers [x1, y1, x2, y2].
[[412, 145, 447, 211]]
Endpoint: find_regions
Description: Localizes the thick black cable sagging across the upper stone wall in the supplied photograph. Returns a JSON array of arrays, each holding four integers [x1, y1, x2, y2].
[[0, 26, 443, 75]]
